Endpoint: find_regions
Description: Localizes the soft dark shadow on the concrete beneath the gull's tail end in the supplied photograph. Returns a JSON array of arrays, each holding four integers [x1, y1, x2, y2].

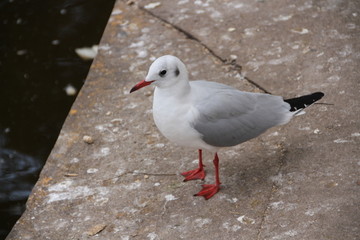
[[220, 133, 311, 198]]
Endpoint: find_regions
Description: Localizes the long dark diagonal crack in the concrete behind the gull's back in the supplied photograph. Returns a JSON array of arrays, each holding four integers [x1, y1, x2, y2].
[[138, 5, 271, 94]]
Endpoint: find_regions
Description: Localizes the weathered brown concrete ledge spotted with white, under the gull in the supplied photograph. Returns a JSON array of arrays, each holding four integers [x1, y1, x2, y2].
[[7, 0, 360, 240]]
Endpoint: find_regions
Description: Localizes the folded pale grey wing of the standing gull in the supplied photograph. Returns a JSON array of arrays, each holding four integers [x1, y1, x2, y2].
[[193, 89, 292, 147]]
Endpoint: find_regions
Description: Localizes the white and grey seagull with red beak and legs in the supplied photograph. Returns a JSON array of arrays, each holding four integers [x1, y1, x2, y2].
[[130, 55, 324, 200]]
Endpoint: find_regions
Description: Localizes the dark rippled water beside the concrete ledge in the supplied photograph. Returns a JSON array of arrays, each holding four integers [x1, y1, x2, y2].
[[0, 0, 115, 239]]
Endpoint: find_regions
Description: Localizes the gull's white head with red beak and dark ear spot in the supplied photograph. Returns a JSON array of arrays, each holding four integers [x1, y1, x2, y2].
[[130, 55, 188, 93]]
